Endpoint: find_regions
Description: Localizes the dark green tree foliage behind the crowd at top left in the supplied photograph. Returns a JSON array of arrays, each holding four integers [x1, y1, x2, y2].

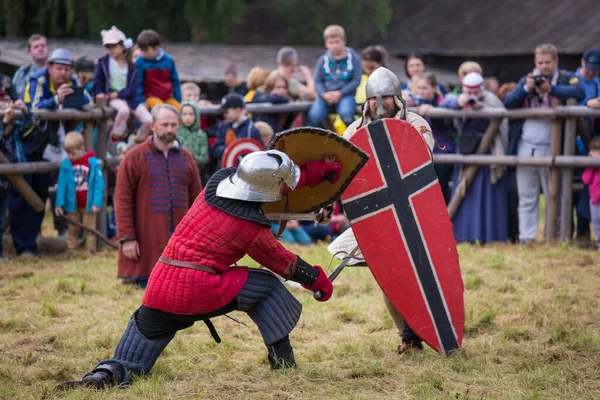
[[0, 0, 392, 45]]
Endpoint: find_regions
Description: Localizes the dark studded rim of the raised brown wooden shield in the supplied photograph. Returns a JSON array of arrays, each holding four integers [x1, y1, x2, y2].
[[266, 126, 369, 213]]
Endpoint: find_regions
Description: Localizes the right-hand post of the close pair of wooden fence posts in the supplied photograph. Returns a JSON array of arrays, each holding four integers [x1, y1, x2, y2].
[[560, 99, 577, 241]]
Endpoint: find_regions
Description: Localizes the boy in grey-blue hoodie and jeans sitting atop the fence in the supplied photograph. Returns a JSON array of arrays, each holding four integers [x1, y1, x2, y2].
[[308, 25, 362, 126]]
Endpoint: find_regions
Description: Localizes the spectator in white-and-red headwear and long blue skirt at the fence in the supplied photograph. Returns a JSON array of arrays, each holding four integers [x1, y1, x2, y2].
[[439, 72, 508, 243]]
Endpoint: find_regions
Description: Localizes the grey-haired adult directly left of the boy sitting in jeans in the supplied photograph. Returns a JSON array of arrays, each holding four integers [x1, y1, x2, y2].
[[277, 47, 317, 101]]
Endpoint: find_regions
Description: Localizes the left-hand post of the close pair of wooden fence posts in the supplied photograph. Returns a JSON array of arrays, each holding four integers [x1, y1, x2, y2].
[[546, 97, 564, 243]]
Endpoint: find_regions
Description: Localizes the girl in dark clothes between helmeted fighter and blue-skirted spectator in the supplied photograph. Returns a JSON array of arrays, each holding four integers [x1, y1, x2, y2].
[[415, 72, 456, 204]]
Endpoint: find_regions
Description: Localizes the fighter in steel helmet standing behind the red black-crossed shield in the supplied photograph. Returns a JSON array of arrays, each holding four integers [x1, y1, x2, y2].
[[328, 67, 435, 354]]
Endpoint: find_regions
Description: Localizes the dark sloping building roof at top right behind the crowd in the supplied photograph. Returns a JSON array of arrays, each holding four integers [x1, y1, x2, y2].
[[386, 0, 600, 57]]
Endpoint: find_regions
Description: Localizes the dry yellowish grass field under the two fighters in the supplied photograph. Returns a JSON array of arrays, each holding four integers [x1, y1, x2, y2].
[[0, 222, 600, 399]]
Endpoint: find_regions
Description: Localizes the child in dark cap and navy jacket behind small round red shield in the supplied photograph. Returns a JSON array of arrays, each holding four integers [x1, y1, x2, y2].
[[212, 93, 261, 163]]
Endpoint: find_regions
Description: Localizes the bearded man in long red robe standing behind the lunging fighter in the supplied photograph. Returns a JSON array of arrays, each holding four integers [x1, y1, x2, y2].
[[115, 104, 202, 288]]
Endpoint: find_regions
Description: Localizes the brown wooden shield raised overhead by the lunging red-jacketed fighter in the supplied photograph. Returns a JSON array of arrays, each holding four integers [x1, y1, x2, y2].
[[263, 127, 369, 213]]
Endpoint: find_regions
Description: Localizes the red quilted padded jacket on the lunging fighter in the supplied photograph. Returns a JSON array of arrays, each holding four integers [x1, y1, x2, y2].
[[143, 191, 297, 315]]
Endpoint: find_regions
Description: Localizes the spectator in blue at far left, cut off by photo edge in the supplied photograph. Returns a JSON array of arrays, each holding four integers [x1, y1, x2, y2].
[[0, 100, 34, 261]]
